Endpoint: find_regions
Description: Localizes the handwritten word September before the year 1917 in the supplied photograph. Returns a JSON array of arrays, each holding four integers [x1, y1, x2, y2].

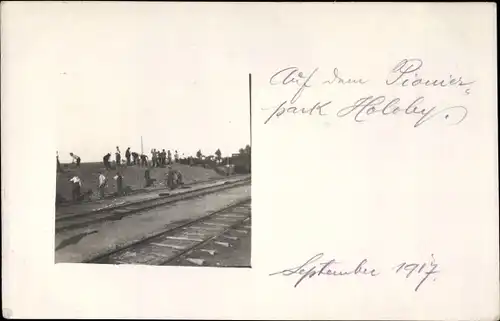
[[269, 253, 379, 288]]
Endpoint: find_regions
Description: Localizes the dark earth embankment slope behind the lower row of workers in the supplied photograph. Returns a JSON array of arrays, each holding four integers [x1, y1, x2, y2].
[[56, 163, 223, 200]]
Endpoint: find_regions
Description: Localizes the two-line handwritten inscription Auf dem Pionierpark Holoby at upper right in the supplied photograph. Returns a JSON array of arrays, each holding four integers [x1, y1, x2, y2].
[[263, 59, 474, 128]]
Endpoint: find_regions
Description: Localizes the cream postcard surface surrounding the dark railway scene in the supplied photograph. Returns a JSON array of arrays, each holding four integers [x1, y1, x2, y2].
[[2, 2, 499, 320]]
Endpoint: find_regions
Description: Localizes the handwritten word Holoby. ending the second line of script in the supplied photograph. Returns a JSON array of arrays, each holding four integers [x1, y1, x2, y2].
[[337, 96, 467, 128]]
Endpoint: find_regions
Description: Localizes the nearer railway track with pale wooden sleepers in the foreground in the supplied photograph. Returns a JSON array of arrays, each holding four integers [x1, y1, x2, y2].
[[85, 198, 251, 265]]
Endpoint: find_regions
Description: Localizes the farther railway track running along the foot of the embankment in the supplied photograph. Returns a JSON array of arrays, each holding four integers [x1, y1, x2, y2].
[[55, 178, 250, 233]]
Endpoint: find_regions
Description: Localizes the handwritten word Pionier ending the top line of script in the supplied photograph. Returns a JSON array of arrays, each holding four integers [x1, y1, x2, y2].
[[385, 59, 474, 95]]
